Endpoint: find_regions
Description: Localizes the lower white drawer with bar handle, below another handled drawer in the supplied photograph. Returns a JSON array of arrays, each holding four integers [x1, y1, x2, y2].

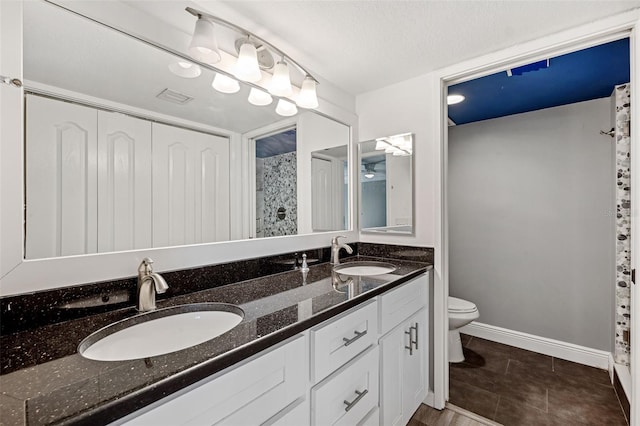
[[311, 347, 378, 426]]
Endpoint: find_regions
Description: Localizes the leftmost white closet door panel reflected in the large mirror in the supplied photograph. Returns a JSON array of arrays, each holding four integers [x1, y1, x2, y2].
[[26, 95, 97, 259]]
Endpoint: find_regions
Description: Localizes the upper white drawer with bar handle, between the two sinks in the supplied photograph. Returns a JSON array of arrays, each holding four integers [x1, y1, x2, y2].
[[311, 301, 378, 383]]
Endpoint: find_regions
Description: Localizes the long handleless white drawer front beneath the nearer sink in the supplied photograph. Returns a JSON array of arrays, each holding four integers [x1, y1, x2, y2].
[[126, 336, 308, 425]]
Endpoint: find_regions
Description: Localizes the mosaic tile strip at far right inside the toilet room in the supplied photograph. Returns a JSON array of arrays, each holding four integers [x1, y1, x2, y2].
[[614, 84, 631, 365]]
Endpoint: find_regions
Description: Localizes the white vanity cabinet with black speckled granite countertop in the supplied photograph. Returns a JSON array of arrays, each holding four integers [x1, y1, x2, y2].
[[0, 256, 431, 425]]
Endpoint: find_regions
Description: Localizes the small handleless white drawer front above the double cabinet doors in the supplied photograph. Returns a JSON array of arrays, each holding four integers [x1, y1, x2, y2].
[[380, 275, 429, 334]]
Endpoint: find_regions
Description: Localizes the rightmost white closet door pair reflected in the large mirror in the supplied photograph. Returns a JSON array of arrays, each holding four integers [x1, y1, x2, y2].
[[152, 123, 229, 247]]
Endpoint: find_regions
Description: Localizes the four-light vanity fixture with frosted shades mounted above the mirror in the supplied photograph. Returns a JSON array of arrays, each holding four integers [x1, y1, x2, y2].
[[186, 7, 318, 115]]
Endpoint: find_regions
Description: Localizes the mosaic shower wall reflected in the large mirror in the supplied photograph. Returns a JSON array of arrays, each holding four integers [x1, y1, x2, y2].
[[263, 151, 298, 237]]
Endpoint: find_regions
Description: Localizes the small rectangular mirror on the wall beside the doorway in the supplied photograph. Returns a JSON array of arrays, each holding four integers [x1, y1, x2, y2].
[[358, 133, 413, 234]]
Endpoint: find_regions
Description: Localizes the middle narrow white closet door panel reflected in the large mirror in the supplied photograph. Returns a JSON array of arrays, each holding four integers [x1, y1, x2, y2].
[[98, 111, 152, 252]]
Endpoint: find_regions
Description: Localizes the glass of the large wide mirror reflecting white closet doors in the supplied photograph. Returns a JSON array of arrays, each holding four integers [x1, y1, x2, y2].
[[23, 1, 351, 259]]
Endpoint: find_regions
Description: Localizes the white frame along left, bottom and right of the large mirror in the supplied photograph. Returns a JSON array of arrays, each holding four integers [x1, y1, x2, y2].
[[0, 1, 358, 296]]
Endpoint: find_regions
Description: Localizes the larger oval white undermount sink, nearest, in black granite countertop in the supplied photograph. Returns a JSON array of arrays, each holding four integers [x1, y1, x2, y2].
[[78, 303, 244, 361]]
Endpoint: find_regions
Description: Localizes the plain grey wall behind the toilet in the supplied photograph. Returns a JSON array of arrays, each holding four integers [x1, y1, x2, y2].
[[448, 98, 615, 351]]
